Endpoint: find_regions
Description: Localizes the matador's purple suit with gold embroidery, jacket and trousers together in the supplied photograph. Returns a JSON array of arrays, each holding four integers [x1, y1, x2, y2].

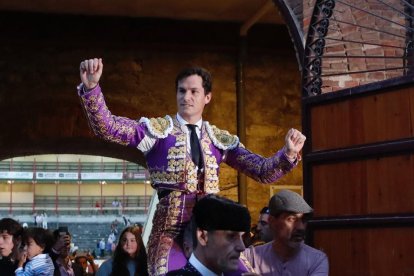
[[78, 86, 296, 275]]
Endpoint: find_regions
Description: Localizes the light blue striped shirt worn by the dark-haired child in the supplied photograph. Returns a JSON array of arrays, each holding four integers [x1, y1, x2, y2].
[[15, 254, 55, 276]]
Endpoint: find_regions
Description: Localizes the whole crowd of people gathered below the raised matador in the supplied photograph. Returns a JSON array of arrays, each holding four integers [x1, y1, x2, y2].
[[0, 190, 329, 276]]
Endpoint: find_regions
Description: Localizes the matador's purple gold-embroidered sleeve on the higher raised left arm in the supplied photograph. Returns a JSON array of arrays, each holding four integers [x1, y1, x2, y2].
[[78, 85, 146, 147]]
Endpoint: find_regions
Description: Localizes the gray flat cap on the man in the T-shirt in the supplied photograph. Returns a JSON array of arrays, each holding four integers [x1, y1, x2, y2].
[[269, 190, 313, 214]]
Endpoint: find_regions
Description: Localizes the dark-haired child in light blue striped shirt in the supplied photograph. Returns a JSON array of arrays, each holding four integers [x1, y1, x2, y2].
[[16, 228, 55, 276]]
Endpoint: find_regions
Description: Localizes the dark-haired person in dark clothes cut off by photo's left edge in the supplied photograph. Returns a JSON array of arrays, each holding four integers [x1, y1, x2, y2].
[[0, 218, 22, 276]]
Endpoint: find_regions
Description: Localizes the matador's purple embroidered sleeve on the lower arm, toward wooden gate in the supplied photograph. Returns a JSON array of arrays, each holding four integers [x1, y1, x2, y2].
[[224, 147, 298, 183]]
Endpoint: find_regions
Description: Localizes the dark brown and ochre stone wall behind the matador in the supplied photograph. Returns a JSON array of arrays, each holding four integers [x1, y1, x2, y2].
[[0, 10, 301, 223]]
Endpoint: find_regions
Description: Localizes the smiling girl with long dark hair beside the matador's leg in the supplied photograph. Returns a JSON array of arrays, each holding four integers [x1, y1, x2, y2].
[[96, 226, 148, 276]]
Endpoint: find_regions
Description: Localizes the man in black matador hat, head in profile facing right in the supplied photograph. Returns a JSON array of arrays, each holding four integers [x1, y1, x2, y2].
[[167, 195, 250, 276]]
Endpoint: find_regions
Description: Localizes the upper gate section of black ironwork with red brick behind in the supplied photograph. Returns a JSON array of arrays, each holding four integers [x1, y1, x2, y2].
[[303, 0, 412, 94]]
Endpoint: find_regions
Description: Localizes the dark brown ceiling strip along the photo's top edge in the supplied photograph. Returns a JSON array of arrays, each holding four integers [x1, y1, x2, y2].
[[0, 0, 283, 24]]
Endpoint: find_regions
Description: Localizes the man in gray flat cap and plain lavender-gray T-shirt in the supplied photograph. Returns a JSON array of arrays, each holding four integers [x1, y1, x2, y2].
[[243, 190, 329, 276]]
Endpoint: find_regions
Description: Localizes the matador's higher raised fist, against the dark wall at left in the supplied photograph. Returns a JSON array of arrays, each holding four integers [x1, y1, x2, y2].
[[79, 58, 103, 89]]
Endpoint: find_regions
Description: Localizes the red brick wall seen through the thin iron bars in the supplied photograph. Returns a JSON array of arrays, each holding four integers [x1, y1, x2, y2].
[[303, 0, 406, 93]]
